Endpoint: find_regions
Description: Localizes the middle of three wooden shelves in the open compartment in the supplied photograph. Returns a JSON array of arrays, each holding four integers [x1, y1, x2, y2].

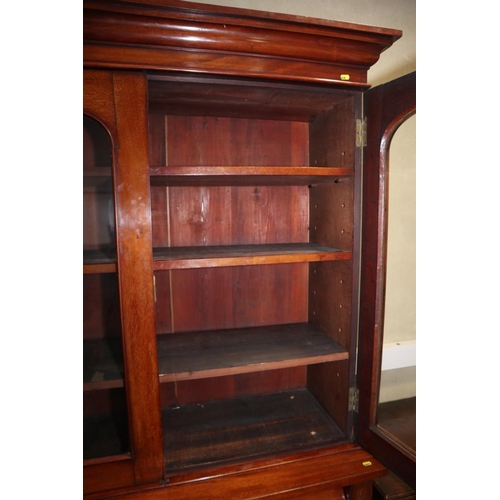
[[153, 243, 352, 271]]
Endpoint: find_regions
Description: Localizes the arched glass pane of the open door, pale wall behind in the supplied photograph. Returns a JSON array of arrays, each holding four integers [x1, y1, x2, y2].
[[377, 116, 416, 455]]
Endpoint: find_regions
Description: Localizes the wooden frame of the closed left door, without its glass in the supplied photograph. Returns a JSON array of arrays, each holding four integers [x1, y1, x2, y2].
[[83, 70, 164, 494]]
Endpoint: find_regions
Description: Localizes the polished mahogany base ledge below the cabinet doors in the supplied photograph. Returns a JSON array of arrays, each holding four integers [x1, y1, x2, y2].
[[86, 443, 387, 500]]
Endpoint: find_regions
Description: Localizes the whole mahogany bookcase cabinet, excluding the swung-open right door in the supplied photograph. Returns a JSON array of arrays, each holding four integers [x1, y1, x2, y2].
[[83, 0, 414, 499]]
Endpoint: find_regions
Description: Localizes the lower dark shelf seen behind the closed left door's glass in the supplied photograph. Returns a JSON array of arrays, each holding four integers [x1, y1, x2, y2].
[[83, 338, 123, 391]]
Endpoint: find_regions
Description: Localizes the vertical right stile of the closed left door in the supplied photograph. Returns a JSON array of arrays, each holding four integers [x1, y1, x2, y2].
[[113, 72, 163, 484]]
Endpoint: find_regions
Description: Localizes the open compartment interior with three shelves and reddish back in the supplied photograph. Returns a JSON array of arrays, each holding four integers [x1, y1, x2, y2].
[[149, 77, 357, 473]]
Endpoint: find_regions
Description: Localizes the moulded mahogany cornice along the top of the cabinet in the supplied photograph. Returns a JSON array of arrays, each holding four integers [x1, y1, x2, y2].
[[83, 0, 401, 89]]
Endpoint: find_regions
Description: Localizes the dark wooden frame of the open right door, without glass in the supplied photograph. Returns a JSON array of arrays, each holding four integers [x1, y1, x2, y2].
[[357, 72, 416, 488]]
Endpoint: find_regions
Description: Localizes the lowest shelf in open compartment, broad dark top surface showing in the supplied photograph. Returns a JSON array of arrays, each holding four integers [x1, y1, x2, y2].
[[158, 323, 348, 382]]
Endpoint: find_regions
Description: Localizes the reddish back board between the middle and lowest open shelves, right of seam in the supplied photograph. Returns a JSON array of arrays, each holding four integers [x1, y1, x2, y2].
[[168, 264, 308, 333]]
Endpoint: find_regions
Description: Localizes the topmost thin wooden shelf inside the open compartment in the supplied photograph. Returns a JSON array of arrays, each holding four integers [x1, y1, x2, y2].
[[149, 166, 354, 186]]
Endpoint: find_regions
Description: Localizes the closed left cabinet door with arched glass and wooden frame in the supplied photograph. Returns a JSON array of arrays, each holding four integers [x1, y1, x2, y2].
[[83, 71, 163, 493]]
